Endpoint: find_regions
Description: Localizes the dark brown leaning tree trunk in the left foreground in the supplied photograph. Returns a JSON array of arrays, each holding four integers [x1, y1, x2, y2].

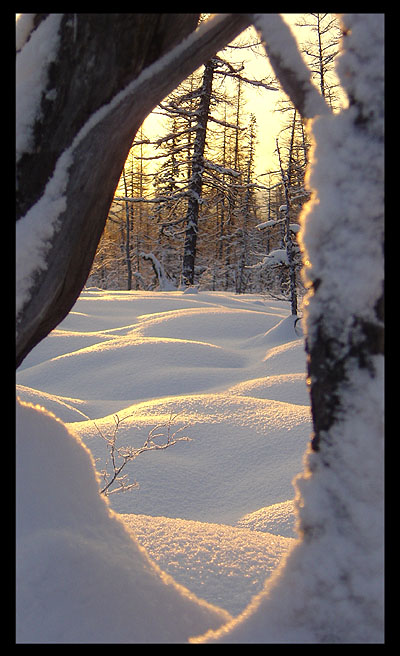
[[17, 14, 250, 366]]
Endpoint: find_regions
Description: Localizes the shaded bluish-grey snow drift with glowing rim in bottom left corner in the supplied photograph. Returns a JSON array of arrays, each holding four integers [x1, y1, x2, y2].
[[16, 403, 229, 644]]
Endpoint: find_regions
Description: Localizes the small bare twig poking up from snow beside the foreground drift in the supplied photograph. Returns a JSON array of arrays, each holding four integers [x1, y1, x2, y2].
[[94, 412, 191, 496]]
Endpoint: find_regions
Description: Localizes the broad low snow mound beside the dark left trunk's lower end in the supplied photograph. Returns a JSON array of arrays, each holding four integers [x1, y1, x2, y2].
[[18, 336, 244, 399]]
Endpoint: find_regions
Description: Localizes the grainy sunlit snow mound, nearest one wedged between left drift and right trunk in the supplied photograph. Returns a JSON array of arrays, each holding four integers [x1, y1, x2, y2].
[[121, 514, 294, 615]]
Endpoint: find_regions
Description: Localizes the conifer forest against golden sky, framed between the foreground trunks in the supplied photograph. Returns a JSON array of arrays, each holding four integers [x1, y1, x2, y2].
[[87, 13, 340, 314]]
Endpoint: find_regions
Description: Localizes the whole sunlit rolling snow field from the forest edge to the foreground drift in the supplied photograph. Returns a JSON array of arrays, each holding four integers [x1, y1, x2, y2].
[[17, 288, 311, 636]]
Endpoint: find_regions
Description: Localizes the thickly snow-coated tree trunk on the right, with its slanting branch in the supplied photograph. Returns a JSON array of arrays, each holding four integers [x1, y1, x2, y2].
[[197, 14, 384, 643]]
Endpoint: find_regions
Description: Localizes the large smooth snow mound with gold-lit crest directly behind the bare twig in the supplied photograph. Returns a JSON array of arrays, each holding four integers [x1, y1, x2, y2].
[[73, 393, 310, 524]]
